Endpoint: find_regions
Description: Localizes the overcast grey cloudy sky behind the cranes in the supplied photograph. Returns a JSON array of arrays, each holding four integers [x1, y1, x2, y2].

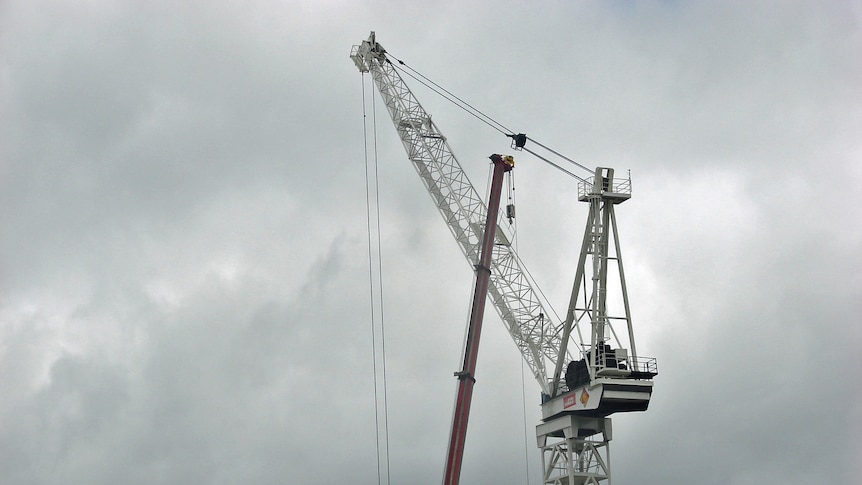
[[0, 0, 862, 485]]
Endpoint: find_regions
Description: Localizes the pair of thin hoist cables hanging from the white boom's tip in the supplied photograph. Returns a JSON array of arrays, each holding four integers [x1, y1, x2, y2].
[[361, 75, 390, 485]]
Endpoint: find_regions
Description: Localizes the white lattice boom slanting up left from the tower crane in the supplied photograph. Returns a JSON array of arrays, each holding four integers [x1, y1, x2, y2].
[[350, 32, 562, 394]]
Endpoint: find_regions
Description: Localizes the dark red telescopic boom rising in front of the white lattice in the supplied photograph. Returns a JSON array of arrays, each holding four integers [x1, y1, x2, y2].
[[443, 155, 515, 485]]
